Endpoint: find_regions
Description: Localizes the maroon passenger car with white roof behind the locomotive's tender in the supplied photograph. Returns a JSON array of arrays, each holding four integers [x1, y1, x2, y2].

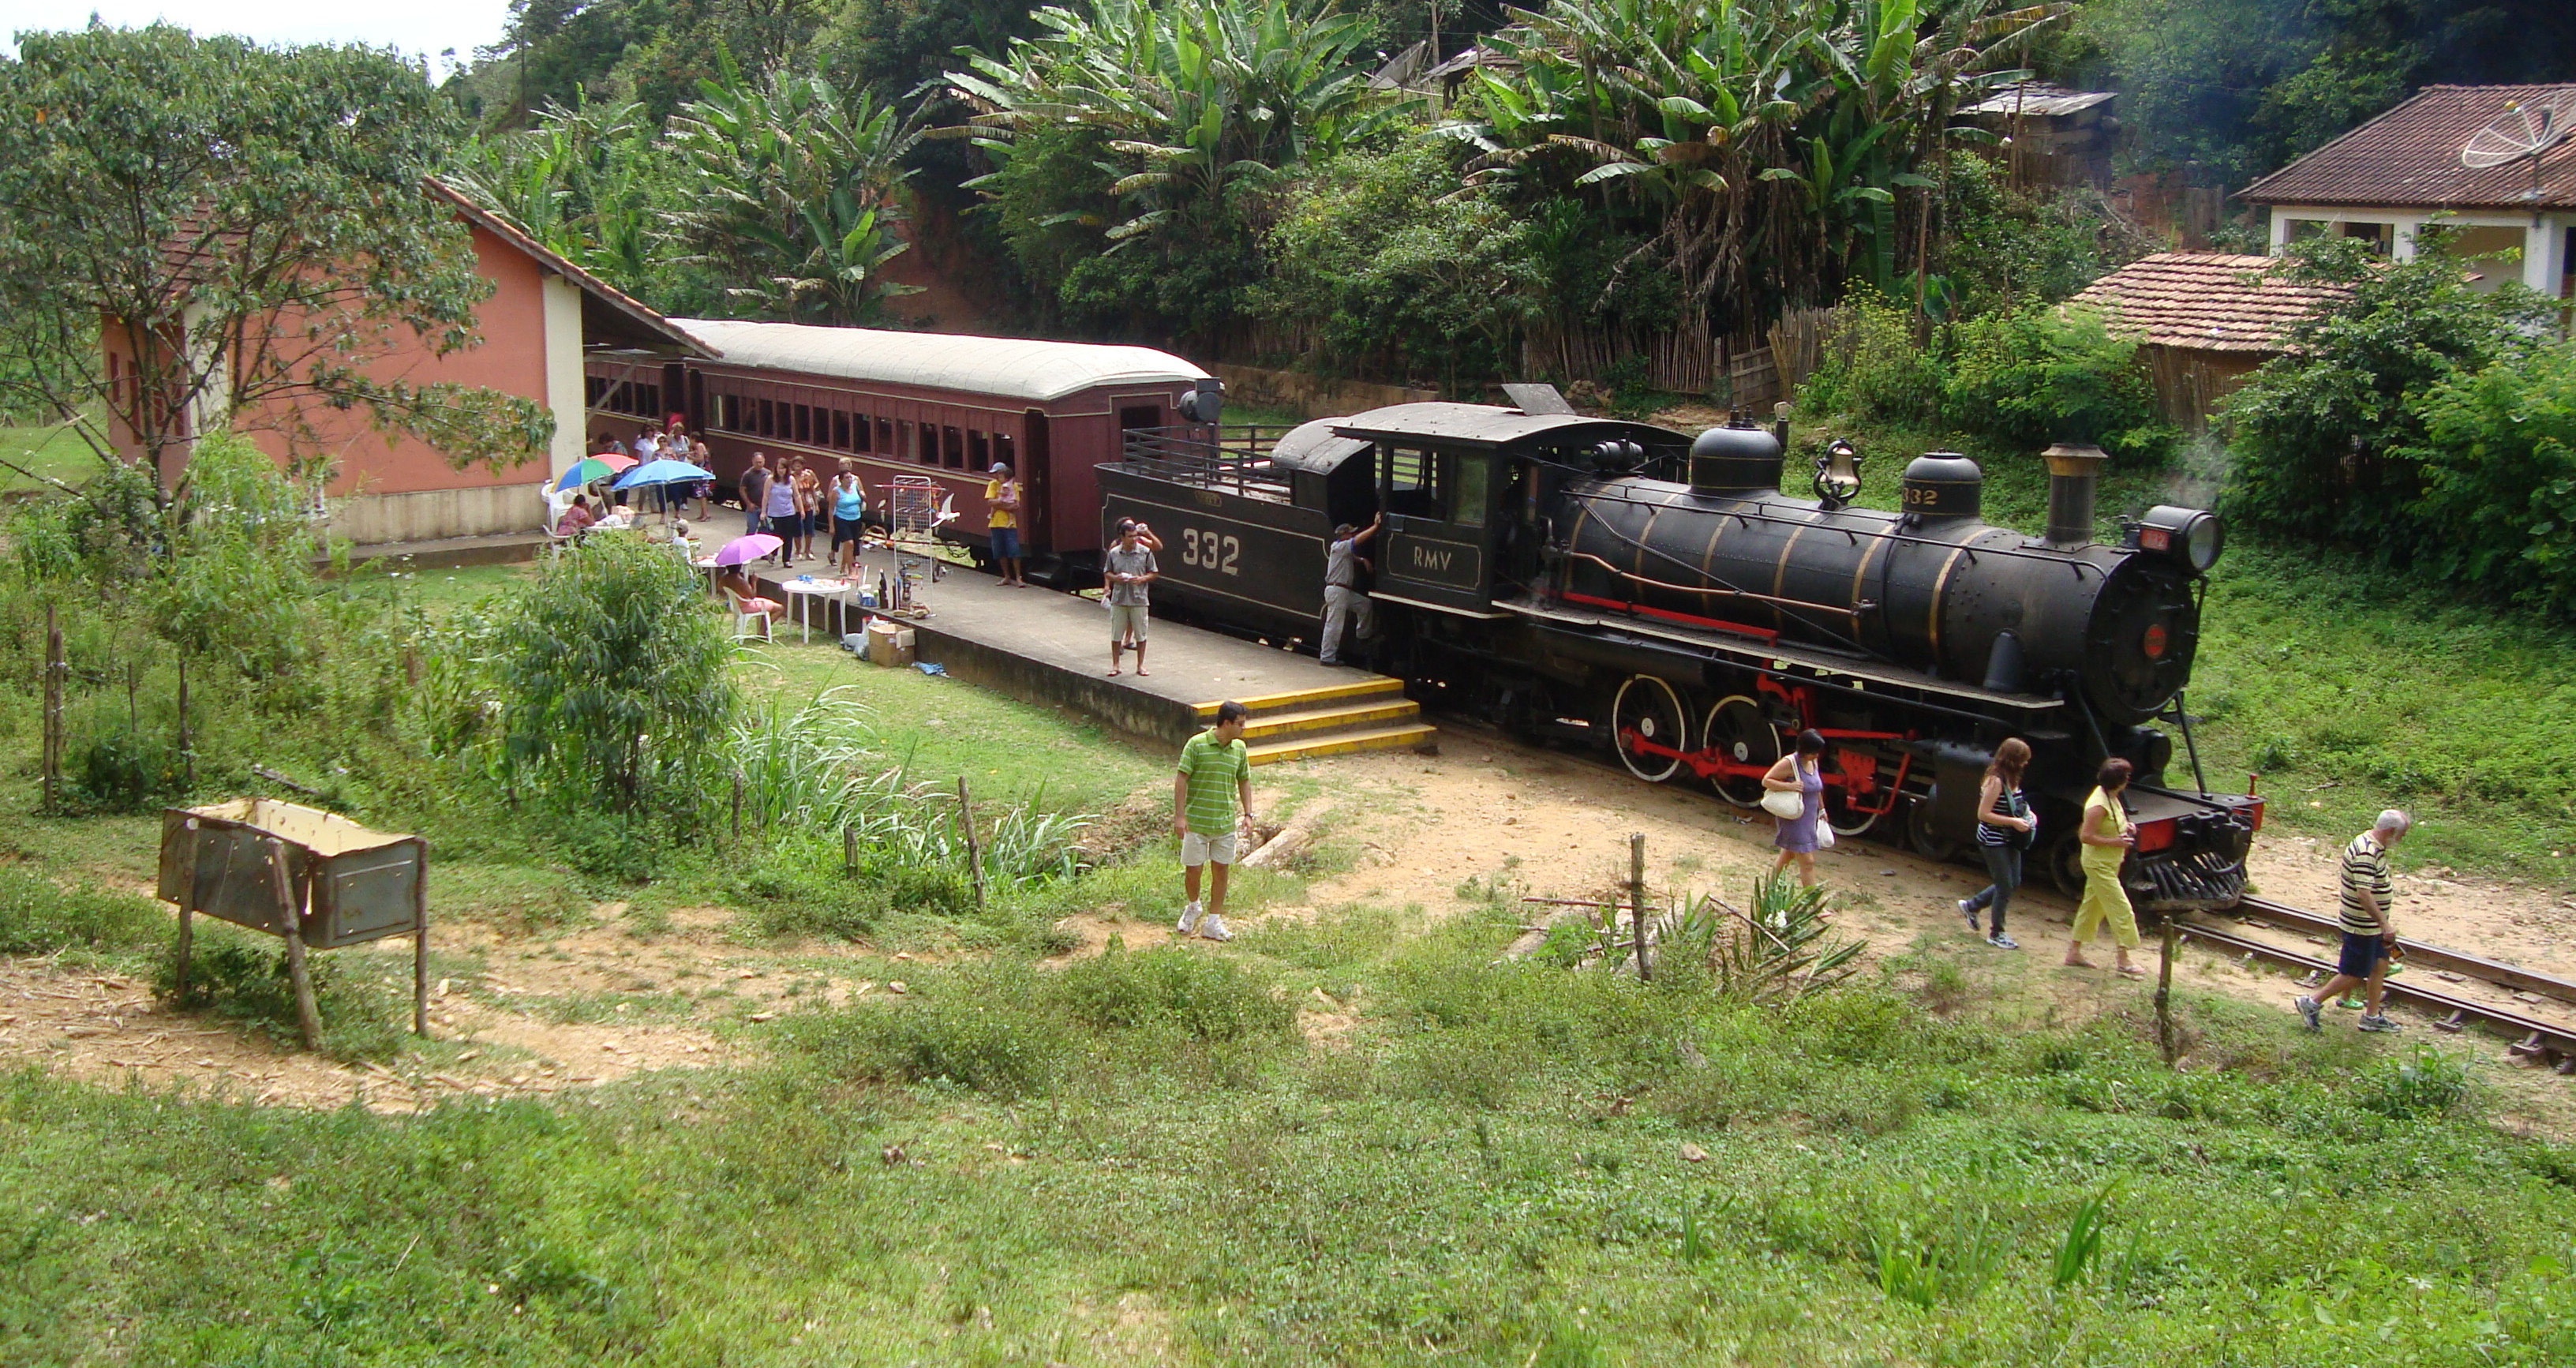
[[587, 320, 1206, 579]]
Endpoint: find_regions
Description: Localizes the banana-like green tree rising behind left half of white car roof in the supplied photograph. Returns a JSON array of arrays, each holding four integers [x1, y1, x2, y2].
[[670, 62, 923, 324]]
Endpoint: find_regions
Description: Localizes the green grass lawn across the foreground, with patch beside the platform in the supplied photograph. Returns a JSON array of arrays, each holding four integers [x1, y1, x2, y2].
[[0, 533, 2576, 1368]]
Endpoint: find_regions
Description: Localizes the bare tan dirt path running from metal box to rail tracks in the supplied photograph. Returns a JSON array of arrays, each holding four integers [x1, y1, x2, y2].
[[15, 724, 2576, 1111]]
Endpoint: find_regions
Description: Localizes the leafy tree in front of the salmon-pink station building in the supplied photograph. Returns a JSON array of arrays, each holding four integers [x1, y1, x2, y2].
[[0, 26, 554, 525]]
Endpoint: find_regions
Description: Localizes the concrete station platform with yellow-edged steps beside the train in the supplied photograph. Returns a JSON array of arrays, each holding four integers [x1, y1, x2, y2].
[[754, 551, 1437, 765]]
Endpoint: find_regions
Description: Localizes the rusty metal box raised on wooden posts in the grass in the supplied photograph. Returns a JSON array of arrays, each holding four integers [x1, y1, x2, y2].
[[159, 799, 428, 950]]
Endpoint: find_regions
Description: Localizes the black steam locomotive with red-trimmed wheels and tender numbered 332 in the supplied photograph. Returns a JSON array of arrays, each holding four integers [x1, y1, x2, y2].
[[1100, 387, 2262, 912]]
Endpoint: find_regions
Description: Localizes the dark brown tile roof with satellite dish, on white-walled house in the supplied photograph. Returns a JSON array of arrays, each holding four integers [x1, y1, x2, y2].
[[2238, 85, 2576, 208]]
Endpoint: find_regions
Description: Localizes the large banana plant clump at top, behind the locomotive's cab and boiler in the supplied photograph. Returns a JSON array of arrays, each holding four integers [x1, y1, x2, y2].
[[1447, 0, 2066, 332]]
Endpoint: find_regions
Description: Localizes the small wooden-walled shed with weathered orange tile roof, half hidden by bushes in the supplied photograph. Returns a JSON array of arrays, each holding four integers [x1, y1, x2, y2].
[[2069, 253, 2344, 428]]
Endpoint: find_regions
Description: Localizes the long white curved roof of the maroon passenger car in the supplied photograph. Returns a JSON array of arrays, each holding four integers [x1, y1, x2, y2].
[[670, 320, 1208, 402]]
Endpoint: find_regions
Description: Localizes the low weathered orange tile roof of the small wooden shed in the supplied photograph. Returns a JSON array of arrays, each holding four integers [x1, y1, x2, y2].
[[2069, 253, 2344, 353]]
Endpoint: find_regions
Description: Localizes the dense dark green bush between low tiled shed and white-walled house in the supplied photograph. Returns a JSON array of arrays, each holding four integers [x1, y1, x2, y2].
[[2226, 229, 2550, 559]]
